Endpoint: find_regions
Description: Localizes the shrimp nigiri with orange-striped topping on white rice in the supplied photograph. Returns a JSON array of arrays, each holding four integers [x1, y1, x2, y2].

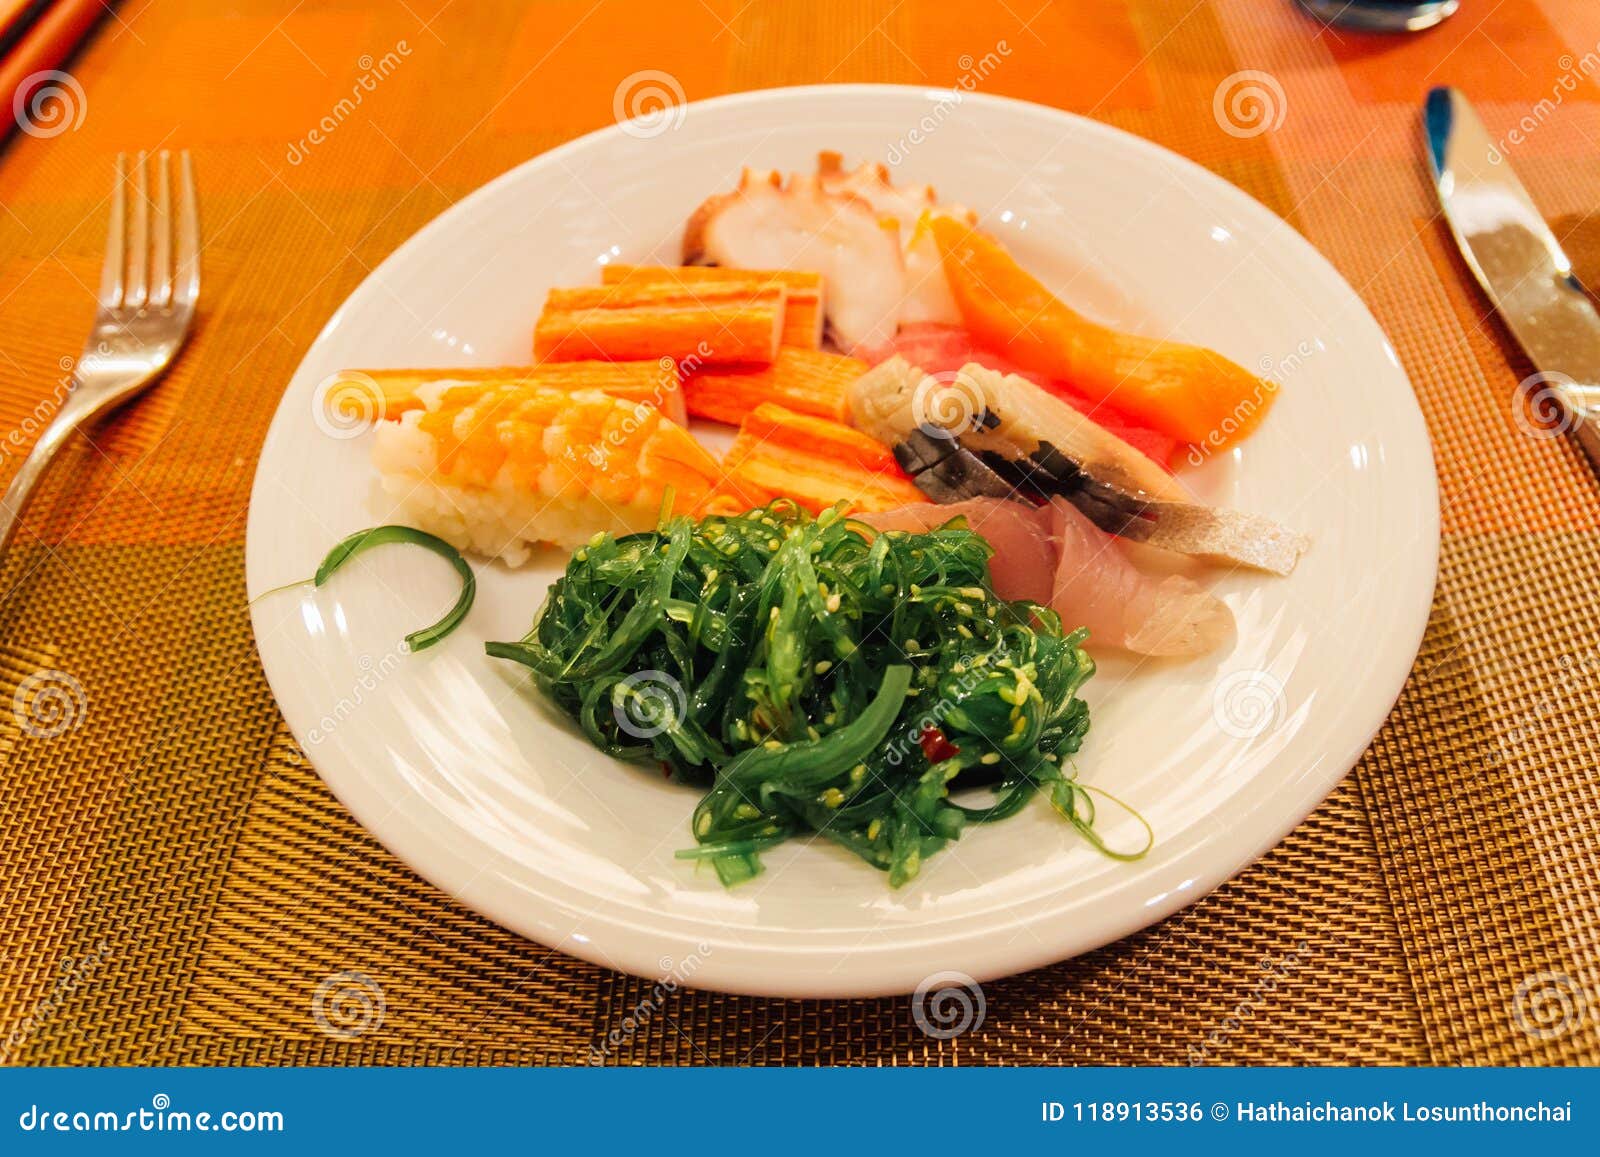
[[373, 381, 722, 566]]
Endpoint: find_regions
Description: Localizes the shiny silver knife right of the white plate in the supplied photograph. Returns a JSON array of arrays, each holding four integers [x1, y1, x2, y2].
[[1424, 88, 1600, 472]]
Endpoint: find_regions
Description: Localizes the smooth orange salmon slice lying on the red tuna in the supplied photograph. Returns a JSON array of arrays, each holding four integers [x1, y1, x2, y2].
[[926, 216, 1277, 448]]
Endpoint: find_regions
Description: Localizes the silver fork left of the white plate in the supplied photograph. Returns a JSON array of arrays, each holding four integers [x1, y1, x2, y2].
[[0, 149, 200, 558]]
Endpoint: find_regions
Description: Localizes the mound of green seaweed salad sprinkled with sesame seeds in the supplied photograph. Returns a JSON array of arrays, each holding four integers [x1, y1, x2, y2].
[[488, 501, 1126, 887]]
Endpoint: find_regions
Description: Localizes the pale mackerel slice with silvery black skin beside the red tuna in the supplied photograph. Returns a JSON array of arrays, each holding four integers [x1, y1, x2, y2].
[[850, 357, 1309, 574]]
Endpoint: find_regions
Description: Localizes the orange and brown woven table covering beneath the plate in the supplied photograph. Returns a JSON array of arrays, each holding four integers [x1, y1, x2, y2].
[[0, 0, 1600, 1064]]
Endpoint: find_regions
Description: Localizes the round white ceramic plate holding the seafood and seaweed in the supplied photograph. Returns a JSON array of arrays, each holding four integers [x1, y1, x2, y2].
[[248, 86, 1438, 997]]
